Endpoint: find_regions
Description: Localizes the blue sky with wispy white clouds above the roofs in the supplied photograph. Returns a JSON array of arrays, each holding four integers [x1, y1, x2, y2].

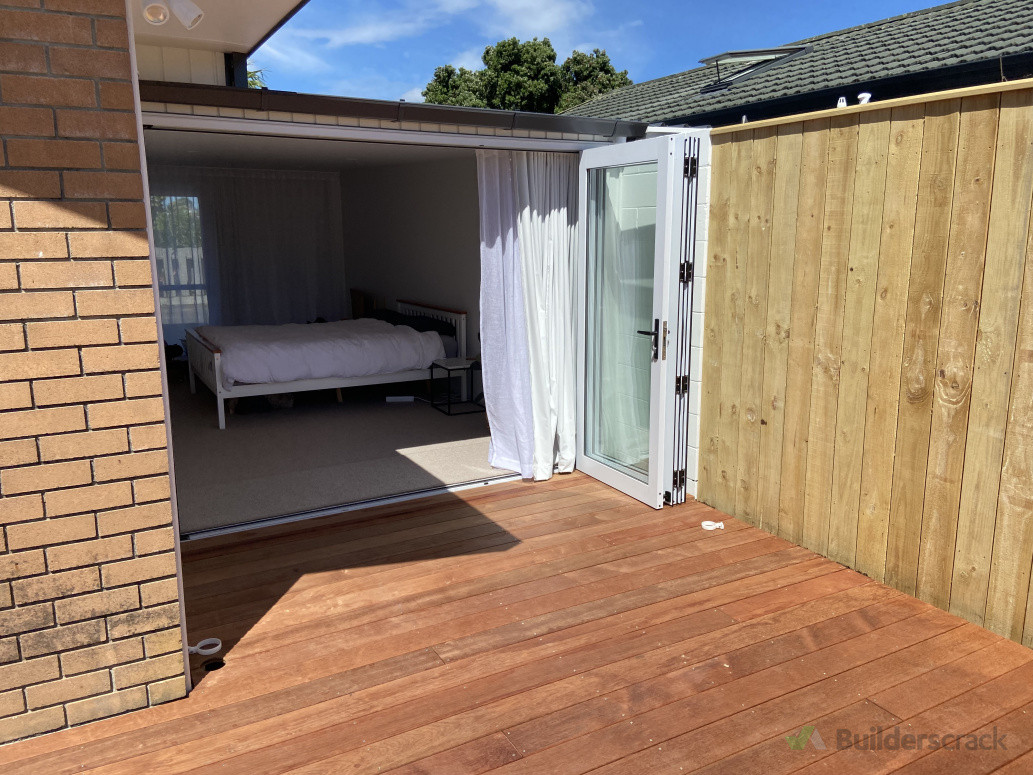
[[252, 0, 937, 100]]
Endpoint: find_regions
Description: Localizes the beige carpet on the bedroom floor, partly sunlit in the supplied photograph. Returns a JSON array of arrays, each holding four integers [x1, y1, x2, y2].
[[169, 371, 510, 533]]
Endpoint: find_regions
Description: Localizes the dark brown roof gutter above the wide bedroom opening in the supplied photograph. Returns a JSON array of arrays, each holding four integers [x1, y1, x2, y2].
[[139, 81, 649, 138]]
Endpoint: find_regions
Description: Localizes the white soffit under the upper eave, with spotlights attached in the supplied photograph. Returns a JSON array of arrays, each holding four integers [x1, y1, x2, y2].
[[129, 0, 299, 53]]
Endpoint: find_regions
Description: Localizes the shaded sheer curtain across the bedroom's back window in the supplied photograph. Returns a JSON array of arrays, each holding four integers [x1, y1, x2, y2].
[[149, 165, 349, 349]]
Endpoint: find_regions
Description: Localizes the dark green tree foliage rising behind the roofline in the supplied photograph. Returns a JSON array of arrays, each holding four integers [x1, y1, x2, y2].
[[422, 37, 631, 113]]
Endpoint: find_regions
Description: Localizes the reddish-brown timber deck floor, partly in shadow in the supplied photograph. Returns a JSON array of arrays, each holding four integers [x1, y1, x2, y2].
[[0, 474, 1033, 775]]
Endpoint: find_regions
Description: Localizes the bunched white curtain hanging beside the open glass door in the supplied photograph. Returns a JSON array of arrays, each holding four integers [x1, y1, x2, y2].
[[477, 151, 577, 479]]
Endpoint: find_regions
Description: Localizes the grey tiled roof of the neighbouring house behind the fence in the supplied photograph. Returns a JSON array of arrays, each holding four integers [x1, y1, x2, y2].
[[567, 0, 1033, 123]]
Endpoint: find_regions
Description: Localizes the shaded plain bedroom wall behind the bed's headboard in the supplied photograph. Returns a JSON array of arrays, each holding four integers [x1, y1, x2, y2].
[[341, 150, 480, 355]]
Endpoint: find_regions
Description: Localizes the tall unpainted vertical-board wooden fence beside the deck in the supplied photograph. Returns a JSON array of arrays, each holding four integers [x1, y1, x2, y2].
[[699, 82, 1033, 645]]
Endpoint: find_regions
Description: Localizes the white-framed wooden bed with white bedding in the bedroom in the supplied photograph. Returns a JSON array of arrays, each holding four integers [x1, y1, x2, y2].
[[186, 301, 466, 430]]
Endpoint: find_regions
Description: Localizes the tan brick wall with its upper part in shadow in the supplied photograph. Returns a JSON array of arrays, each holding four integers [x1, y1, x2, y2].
[[0, 0, 185, 743]]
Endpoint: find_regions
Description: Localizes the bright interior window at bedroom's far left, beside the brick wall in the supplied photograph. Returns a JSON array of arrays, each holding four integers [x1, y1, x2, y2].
[[151, 195, 209, 342]]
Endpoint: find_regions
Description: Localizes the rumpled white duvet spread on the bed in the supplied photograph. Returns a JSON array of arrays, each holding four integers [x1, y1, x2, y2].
[[197, 318, 445, 388]]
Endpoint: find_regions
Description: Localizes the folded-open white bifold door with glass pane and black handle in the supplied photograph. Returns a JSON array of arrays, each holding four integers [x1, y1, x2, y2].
[[576, 133, 701, 508]]
